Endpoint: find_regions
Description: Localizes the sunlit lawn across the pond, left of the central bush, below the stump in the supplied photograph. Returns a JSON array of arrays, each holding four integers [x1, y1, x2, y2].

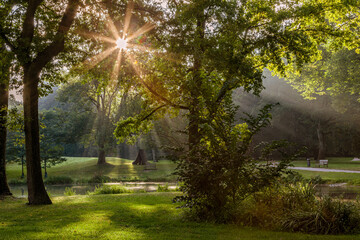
[[6, 157, 176, 181]]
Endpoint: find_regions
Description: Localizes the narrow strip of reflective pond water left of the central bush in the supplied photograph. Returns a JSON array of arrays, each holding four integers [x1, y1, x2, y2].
[[9, 182, 177, 197]]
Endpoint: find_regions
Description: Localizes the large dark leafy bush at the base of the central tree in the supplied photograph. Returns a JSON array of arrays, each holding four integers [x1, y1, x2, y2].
[[175, 104, 294, 222]]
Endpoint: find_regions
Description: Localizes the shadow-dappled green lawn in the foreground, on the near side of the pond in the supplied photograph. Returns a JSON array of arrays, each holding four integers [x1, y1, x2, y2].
[[0, 193, 360, 240]]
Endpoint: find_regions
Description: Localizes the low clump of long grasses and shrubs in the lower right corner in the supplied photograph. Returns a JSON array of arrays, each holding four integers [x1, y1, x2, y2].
[[236, 182, 360, 234]]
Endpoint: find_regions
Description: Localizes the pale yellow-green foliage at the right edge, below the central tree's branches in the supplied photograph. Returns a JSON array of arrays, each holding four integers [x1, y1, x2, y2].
[[287, 48, 359, 107]]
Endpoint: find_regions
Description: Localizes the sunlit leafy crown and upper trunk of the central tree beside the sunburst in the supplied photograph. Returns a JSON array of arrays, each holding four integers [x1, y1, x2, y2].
[[116, 0, 359, 152]]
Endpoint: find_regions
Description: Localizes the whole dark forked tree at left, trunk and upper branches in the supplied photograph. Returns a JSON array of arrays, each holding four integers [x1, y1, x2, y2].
[[0, 0, 80, 204]]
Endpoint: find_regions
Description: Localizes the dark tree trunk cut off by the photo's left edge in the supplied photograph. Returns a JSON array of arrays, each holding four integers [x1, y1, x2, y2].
[[0, 79, 11, 196]]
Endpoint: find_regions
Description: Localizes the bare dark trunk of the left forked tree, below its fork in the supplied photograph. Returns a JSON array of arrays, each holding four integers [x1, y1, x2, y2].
[[23, 68, 51, 204]]
